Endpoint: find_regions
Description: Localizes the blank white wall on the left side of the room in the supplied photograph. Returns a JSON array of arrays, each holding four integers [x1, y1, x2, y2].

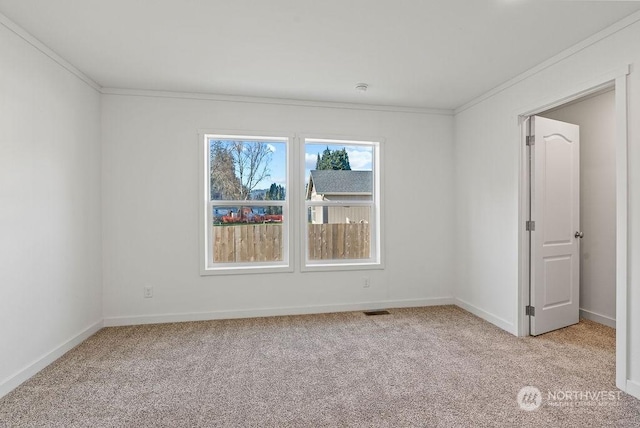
[[0, 24, 102, 396]]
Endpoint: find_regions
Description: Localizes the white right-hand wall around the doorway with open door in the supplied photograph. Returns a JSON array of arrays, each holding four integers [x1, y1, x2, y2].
[[455, 22, 640, 395]]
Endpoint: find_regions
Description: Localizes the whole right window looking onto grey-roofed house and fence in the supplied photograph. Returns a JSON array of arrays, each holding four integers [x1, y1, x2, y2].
[[302, 138, 381, 270]]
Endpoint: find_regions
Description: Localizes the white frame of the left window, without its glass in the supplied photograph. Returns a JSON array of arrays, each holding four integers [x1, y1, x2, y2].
[[198, 130, 295, 276]]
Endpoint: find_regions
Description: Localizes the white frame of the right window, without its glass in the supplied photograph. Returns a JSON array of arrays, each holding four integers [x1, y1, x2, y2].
[[299, 135, 384, 272]]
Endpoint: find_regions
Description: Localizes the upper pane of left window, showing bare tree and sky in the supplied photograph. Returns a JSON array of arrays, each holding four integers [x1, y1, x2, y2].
[[208, 136, 287, 201]]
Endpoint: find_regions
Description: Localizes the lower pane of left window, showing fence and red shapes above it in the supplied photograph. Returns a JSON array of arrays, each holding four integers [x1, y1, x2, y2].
[[211, 205, 284, 263]]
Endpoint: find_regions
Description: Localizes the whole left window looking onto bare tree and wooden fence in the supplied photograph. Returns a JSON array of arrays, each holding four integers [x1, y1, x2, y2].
[[201, 134, 290, 274]]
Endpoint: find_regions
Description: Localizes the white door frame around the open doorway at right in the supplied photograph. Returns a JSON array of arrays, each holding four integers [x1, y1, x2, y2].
[[516, 65, 630, 391]]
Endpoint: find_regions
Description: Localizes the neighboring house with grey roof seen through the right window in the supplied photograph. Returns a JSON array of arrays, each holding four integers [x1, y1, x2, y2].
[[306, 169, 373, 224]]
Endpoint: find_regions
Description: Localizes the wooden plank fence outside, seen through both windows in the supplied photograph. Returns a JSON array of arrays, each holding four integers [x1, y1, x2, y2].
[[213, 223, 371, 263]]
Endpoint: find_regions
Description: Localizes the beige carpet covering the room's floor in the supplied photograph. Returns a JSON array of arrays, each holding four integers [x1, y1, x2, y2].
[[0, 306, 640, 427]]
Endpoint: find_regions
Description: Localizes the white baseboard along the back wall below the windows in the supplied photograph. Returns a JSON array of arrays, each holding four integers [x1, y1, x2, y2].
[[104, 297, 455, 327]]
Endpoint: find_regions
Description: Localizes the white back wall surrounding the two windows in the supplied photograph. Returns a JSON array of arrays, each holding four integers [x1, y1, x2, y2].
[[102, 92, 454, 325]]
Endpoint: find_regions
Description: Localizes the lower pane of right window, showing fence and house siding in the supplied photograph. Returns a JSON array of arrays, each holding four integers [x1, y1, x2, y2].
[[307, 206, 373, 260]]
